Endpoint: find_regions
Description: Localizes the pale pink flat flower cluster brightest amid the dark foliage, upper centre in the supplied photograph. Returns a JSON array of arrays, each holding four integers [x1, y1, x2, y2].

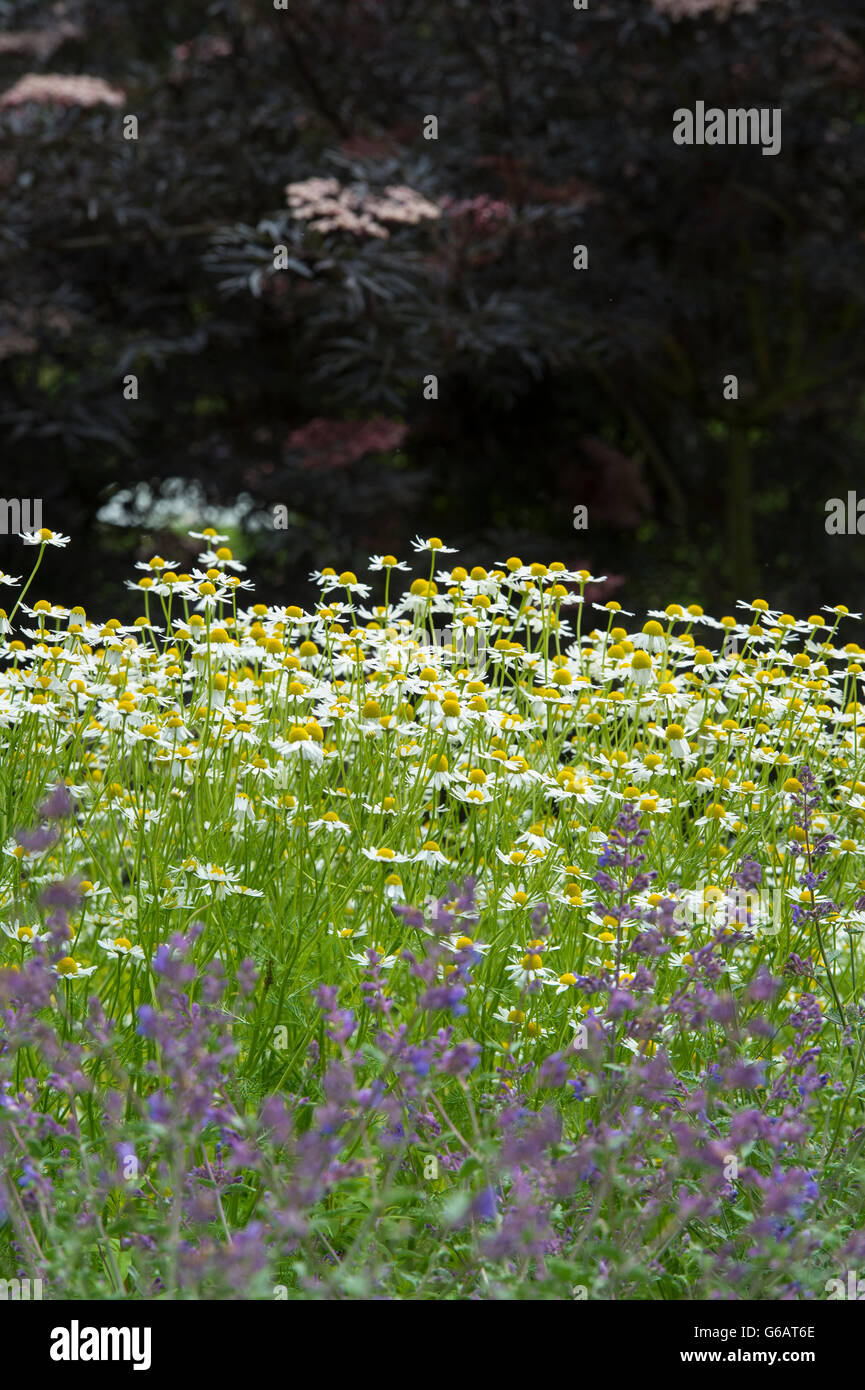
[[285, 178, 441, 239]]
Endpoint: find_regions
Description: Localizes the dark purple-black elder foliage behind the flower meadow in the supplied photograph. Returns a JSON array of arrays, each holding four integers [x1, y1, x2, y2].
[[0, 0, 865, 616]]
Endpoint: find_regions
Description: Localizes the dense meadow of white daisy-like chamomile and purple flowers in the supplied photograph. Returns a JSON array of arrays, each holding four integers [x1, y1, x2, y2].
[[0, 530, 865, 1300]]
